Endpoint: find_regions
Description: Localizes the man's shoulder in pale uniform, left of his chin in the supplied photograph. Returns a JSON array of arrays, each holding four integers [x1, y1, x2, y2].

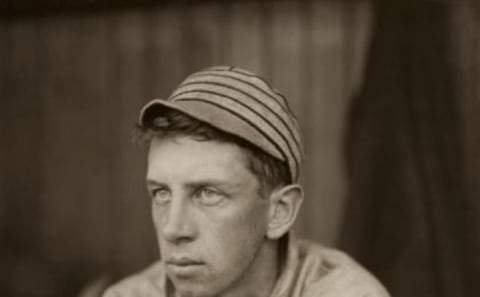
[[103, 262, 166, 297]]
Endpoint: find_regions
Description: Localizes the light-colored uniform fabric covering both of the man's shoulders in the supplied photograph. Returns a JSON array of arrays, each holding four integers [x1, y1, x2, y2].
[[104, 234, 390, 297]]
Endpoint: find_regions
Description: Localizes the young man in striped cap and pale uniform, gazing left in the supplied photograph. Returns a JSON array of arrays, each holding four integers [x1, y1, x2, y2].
[[104, 67, 388, 297]]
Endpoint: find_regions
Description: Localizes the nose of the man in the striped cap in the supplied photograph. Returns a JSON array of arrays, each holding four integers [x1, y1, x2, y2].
[[161, 199, 195, 245]]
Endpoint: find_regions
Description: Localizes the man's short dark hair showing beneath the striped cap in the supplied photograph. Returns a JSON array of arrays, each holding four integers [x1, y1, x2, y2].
[[133, 110, 292, 197]]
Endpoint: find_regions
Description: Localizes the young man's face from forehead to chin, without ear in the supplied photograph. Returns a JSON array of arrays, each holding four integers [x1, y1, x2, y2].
[[147, 136, 269, 296]]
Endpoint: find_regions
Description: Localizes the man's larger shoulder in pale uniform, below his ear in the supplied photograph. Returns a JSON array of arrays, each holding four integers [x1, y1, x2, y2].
[[298, 240, 390, 297]]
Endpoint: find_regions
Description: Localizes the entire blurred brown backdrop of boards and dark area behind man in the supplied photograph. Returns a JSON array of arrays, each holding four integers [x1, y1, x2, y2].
[[0, 0, 480, 297]]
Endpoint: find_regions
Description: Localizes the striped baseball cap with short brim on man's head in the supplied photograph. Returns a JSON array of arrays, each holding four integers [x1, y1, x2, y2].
[[139, 66, 304, 182]]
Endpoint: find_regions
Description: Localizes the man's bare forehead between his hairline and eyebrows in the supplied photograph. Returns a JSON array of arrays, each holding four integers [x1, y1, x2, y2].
[[147, 136, 255, 179]]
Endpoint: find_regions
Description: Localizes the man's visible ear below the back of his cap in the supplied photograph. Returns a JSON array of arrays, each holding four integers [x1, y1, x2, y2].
[[267, 184, 303, 239]]
